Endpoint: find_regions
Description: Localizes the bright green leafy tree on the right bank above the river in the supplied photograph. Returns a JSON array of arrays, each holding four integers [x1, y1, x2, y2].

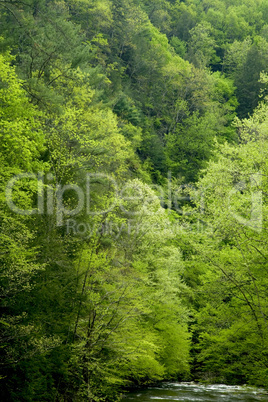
[[186, 104, 268, 386]]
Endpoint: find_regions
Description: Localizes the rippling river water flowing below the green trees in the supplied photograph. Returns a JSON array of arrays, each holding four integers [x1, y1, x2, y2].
[[123, 382, 268, 402]]
